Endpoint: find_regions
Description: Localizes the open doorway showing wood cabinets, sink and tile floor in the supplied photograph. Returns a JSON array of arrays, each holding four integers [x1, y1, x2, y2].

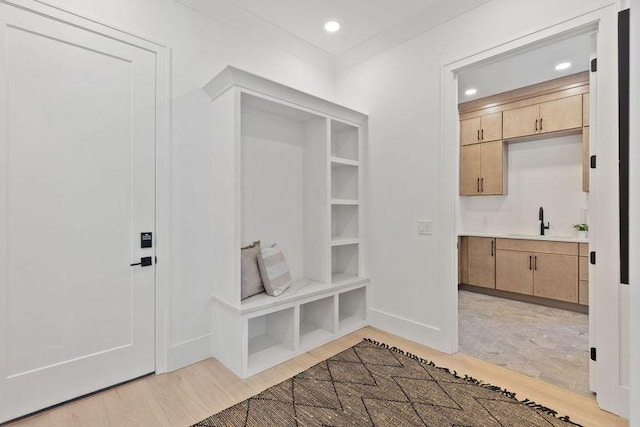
[[456, 31, 596, 395]]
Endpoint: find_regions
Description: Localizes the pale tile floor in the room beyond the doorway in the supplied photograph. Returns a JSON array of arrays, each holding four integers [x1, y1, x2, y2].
[[458, 291, 591, 394]]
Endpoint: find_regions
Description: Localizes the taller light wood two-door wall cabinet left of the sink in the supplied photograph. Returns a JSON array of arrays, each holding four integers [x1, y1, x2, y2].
[[460, 141, 506, 196]]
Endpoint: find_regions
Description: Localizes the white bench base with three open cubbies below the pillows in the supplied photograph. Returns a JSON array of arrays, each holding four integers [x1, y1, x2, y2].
[[213, 277, 369, 378]]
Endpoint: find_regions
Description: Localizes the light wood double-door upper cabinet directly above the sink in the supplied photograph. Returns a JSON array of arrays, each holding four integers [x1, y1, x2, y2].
[[503, 95, 583, 139]]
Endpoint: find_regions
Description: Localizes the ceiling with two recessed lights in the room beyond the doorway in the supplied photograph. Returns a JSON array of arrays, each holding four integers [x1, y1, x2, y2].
[[458, 34, 591, 102]]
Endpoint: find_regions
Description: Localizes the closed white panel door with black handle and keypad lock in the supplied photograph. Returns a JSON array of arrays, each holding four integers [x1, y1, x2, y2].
[[0, 4, 156, 422]]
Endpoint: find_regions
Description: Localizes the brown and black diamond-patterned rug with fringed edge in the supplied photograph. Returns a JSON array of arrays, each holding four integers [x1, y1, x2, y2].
[[195, 340, 578, 427]]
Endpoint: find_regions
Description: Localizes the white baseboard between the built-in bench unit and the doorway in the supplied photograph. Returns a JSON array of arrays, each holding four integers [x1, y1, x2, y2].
[[367, 308, 444, 351]]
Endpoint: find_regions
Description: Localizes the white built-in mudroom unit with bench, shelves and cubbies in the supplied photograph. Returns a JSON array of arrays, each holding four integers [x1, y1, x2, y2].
[[204, 67, 369, 378]]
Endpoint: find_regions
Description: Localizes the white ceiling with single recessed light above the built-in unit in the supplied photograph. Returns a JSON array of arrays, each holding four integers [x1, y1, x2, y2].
[[222, 0, 488, 56]]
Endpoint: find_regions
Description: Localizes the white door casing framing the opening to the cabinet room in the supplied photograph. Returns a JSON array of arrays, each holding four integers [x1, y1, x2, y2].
[[439, 1, 629, 416]]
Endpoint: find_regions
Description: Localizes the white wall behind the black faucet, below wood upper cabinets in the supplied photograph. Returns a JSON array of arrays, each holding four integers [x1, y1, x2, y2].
[[460, 135, 588, 237]]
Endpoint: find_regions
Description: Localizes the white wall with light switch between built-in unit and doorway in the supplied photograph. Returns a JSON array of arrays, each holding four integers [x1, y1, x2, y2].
[[337, 0, 611, 354]]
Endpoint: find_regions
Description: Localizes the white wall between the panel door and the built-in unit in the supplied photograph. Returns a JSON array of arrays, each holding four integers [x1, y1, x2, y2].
[[40, 0, 335, 369]]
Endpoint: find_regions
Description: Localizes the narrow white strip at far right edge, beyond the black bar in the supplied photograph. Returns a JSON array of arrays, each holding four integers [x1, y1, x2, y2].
[[629, 0, 640, 427]]
